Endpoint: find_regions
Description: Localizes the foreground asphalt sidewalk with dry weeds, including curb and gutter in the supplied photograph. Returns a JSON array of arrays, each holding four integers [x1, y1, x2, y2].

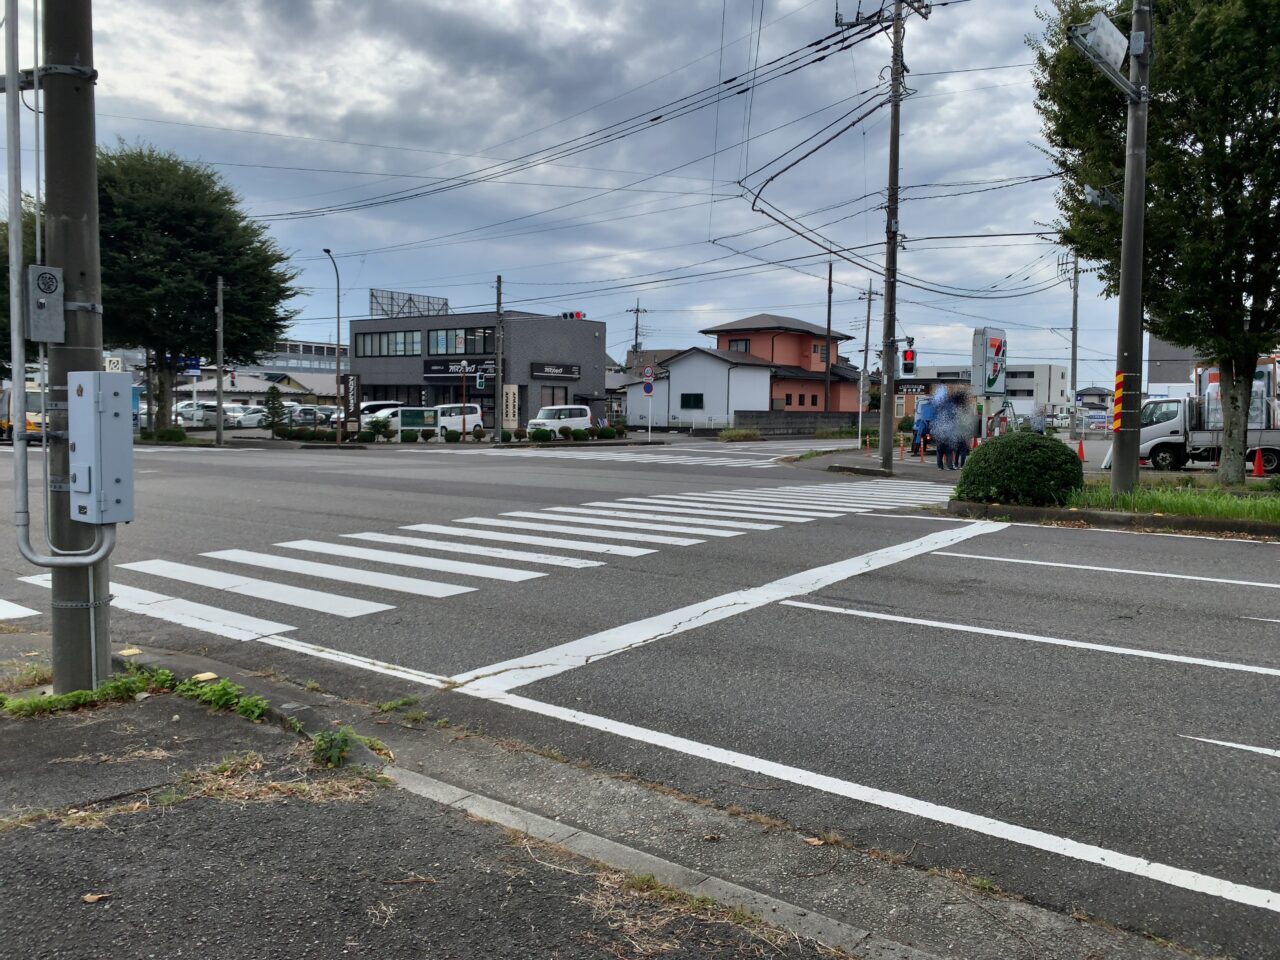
[[0, 635, 1190, 960]]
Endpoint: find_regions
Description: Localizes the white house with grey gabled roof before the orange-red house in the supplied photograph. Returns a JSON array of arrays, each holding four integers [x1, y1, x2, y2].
[[626, 347, 776, 429]]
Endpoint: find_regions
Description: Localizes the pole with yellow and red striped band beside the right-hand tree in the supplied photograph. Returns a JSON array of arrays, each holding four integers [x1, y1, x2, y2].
[[1111, 0, 1151, 494]]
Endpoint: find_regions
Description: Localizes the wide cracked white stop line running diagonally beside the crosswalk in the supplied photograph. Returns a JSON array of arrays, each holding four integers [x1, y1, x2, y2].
[[453, 524, 1005, 690]]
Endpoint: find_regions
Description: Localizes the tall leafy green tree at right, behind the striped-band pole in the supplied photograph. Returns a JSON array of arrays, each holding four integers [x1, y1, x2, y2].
[[1028, 0, 1280, 484]]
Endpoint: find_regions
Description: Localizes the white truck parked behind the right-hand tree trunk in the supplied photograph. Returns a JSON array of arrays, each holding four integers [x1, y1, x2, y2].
[[1138, 393, 1280, 474]]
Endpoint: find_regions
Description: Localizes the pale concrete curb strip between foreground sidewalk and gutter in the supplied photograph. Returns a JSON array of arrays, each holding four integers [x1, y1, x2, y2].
[[383, 767, 936, 960]]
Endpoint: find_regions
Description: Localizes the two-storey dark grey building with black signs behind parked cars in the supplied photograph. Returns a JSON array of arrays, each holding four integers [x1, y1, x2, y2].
[[351, 310, 608, 428]]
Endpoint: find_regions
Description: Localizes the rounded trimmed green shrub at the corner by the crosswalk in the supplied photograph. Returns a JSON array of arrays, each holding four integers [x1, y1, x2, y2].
[[955, 431, 1084, 507]]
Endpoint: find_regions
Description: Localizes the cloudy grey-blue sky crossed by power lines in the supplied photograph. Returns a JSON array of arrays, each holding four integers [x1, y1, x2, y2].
[[23, 0, 1124, 385]]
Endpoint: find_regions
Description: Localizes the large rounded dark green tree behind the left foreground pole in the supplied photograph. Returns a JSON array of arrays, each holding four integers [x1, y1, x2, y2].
[[97, 143, 298, 425]]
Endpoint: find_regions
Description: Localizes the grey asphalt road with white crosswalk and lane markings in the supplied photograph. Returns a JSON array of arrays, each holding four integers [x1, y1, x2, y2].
[[0, 442, 1280, 957]]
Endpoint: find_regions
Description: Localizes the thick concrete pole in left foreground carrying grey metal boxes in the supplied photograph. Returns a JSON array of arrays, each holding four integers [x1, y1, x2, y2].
[[45, 0, 111, 692]]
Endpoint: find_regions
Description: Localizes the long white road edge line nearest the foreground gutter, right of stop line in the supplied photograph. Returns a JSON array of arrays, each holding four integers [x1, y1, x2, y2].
[[462, 686, 1280, 913]]
